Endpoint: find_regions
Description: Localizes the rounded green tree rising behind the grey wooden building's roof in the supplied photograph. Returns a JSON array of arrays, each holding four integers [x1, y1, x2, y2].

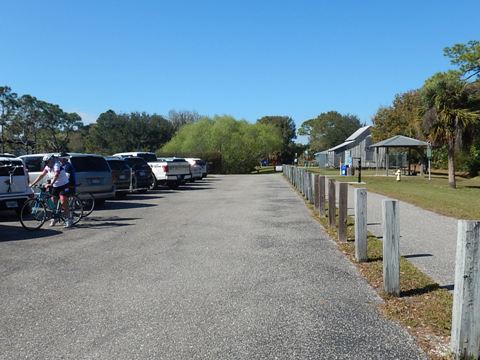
[[298, 111, 362, 152]]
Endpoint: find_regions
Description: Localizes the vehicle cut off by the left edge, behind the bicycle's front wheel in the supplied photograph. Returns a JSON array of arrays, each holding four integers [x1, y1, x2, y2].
[[0, 155, 33, 214]]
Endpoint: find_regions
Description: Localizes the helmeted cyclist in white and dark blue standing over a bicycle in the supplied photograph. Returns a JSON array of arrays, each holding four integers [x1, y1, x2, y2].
[[30, 154, 73, 228]]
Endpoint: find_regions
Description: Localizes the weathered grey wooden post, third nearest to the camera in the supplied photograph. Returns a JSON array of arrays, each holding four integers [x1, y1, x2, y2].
[[354, 189, 368, 262]]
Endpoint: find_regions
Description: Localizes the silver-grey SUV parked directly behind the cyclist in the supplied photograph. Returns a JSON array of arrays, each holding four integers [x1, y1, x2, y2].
[[20, 153, 115, 206]]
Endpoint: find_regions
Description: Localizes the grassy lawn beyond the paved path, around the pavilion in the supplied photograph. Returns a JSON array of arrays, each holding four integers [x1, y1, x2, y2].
[[310, 168, 480, 220]]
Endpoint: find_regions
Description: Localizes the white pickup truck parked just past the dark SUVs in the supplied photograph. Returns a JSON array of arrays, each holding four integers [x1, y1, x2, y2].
[[113, 152, 191, 189]]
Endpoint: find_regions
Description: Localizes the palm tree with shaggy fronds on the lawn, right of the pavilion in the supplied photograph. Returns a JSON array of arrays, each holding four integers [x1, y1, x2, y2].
[[421, 71, 480, 188]]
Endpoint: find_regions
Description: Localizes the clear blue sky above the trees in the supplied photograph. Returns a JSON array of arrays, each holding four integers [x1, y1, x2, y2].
[[0, 0, 480, 143]]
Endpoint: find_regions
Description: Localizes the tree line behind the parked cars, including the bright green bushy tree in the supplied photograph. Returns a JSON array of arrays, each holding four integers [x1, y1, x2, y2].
[[0, 86, 302, 173]]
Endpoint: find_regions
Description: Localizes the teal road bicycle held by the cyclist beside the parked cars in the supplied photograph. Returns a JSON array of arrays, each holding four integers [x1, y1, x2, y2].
[[20, 186, 83, 230]]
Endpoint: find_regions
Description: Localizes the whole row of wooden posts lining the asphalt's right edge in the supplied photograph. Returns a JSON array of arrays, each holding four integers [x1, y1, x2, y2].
[[283, 165, 480, 359]]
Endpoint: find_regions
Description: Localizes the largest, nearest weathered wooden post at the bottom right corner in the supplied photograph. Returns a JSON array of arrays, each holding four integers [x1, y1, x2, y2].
[[451, 220, 480, 359]]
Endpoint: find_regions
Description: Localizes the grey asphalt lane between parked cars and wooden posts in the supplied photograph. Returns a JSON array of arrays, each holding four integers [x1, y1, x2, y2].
[[0, 175, 425, 360]]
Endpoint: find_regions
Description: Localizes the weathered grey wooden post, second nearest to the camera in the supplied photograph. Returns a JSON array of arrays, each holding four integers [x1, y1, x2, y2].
[[382, 200, 400, 296]]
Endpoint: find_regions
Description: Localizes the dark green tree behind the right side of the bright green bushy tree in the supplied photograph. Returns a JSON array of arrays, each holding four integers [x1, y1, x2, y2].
[[257, 116, 297, 164]]
